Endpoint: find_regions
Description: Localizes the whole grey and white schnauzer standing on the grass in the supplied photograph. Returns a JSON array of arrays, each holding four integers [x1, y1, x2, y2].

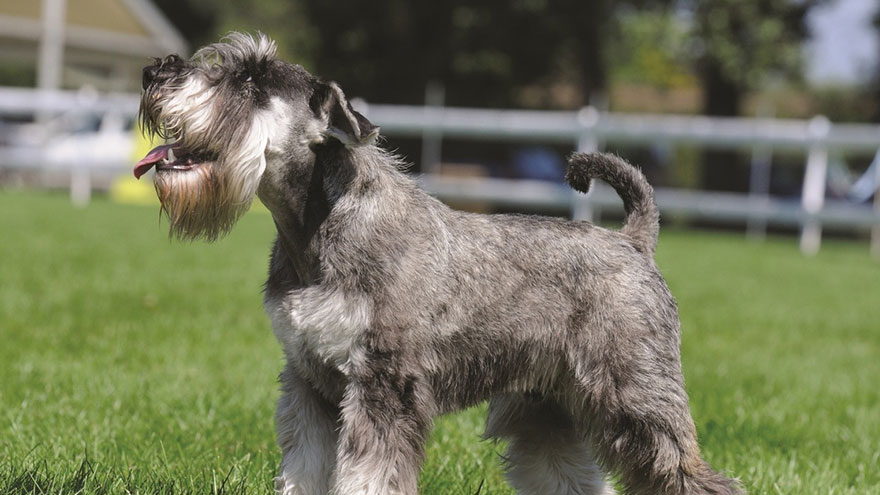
[[135, 33, 740, 495]]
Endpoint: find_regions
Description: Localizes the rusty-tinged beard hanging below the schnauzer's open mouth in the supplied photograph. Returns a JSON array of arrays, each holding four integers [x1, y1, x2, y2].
[[154, 162, 254, 241]]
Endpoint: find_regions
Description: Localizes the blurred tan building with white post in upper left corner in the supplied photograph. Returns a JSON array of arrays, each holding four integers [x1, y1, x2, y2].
[[0, 0, 188, 91]]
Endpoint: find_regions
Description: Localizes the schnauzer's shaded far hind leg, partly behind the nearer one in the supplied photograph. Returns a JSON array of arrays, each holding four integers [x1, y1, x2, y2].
[[485, 394, 614, 495]]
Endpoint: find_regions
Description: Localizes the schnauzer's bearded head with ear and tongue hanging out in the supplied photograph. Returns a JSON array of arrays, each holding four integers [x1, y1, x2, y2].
[[134, 33, 378, 240]]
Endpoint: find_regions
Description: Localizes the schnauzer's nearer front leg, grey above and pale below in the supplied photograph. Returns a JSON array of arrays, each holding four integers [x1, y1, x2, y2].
[[332, 374, 433, 495]]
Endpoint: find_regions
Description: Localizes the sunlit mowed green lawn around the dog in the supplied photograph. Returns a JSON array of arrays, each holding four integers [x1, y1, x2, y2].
[[0, 192, 880, 495]]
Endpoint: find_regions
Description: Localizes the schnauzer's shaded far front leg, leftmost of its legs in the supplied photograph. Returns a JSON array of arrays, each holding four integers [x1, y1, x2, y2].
[[275, 363, 339, 495]]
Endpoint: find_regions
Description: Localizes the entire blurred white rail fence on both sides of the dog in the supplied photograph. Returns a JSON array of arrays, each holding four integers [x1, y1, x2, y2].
[[0, 88, 880, 257]]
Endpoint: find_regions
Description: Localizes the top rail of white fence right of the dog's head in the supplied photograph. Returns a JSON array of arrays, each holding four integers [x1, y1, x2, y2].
[[357, 103, 880, 152]]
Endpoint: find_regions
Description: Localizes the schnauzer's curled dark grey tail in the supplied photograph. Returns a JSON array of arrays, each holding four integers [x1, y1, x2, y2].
[[565, 153, 660, 255]]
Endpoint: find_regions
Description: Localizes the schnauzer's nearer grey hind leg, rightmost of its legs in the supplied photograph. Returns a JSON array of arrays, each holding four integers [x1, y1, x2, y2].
[[568, 334, 742, 495]]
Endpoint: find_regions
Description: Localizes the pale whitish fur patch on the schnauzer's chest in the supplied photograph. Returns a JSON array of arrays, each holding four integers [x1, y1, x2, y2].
[[265, 287, 372, 371]]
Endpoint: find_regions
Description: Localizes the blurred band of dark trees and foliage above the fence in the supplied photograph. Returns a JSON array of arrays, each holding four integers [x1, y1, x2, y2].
[[157, 0, 827, 114]]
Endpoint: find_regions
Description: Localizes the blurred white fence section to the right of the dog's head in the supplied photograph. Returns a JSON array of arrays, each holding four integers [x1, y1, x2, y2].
[[356, 102, 880, 257]]
